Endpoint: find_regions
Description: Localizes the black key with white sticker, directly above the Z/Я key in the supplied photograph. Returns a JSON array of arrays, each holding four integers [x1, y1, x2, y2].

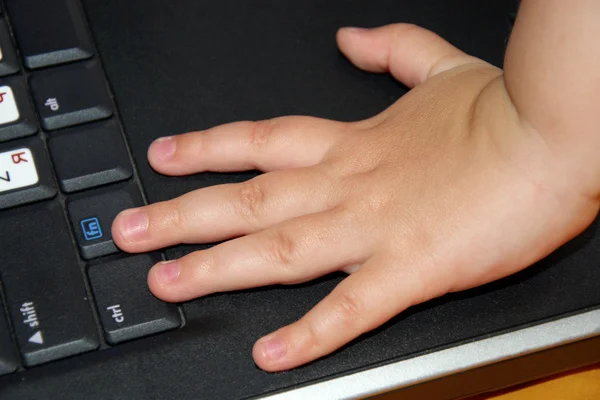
[[0, 77, 38, 142]]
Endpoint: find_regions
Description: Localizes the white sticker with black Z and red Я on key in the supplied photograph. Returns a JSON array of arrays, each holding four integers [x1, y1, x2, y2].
[[0, 148, 39, 193]]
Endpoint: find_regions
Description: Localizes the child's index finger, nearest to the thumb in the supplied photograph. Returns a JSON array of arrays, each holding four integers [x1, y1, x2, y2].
[[148, 117, 346, 175]]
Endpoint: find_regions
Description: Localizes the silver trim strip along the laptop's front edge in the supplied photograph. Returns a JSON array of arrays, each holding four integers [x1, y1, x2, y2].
[[264, 309, 600, 400]]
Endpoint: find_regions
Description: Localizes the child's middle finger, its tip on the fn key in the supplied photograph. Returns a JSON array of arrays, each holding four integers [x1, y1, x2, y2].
[[112, 166, 339, 252]]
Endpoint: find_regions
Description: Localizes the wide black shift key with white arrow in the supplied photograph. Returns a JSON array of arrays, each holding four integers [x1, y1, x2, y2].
[[0, 202, 98, 366]]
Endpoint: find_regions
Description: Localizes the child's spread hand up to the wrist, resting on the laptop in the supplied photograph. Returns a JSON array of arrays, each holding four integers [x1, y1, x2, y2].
[[113, 24, 598, 371]]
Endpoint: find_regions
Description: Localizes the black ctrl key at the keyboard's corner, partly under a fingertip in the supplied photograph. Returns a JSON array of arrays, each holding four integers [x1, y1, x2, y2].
[[88, 254, 181, 344]]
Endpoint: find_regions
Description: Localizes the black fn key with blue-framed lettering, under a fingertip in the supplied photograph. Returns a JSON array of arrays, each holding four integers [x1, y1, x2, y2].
[[67, 185, 143, 260]]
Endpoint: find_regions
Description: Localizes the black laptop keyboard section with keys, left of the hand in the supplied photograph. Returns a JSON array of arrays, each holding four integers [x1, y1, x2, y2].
[[0, 0, 182, 374]]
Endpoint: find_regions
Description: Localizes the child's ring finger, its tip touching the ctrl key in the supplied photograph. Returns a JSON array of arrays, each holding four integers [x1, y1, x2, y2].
[[148, 209, 372, 302]]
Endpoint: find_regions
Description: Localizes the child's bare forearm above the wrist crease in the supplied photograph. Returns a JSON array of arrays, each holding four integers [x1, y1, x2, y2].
[[505, 0, 600, 198]]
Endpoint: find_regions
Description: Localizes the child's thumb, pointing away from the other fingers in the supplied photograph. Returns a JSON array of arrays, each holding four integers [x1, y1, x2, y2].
[[337, 24, 483, 88]]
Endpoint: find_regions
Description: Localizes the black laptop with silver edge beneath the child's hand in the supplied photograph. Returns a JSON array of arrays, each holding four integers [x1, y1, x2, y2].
[[0, 0, 600, 399]]
